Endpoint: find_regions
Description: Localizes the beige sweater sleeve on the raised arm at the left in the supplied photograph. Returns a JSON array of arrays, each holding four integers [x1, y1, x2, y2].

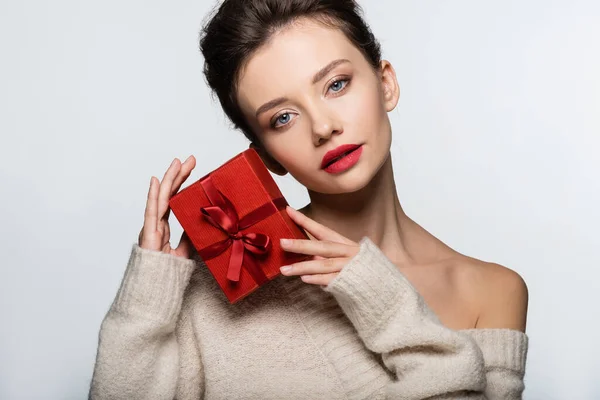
[[89, 244, 200, 400]]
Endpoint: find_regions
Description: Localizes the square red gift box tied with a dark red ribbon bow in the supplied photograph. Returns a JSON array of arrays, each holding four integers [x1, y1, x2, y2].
[[169, 149, 308, 303]]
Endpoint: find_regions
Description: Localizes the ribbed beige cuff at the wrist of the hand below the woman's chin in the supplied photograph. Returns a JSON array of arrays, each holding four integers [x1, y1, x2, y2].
[[323, 236, 414, 339]]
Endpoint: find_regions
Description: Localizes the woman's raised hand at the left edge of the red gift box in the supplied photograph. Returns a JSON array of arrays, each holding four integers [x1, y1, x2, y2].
[[138, 156, 196, 258]]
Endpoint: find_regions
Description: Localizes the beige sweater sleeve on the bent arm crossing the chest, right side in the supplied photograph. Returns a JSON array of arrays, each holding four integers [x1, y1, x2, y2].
[[324, 237, 518, 399]]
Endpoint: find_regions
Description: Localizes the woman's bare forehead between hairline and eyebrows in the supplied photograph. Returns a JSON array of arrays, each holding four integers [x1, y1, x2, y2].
[[238, 20, 366, 111]]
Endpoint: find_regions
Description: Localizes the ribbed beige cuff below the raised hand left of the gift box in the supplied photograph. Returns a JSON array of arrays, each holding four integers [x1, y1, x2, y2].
[[112, 243, 196, 323]]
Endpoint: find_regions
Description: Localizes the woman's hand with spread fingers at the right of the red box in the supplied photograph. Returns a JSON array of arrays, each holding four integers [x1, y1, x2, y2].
[[281, 206, 360, 286]]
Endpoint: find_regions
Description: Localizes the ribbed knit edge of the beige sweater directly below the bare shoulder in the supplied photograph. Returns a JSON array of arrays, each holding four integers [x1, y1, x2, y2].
[[461, 329, 529, 377]]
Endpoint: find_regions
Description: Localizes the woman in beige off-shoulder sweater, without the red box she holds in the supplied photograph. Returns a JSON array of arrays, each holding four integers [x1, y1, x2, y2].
[[90, 0, 528, 400]]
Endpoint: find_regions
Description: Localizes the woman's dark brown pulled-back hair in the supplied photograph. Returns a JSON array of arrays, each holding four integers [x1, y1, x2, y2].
[[200, 0, 381, 144]]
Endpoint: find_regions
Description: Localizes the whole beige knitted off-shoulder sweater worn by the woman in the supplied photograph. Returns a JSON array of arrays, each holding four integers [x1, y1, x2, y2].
[[90, 237, 528, 400]]
